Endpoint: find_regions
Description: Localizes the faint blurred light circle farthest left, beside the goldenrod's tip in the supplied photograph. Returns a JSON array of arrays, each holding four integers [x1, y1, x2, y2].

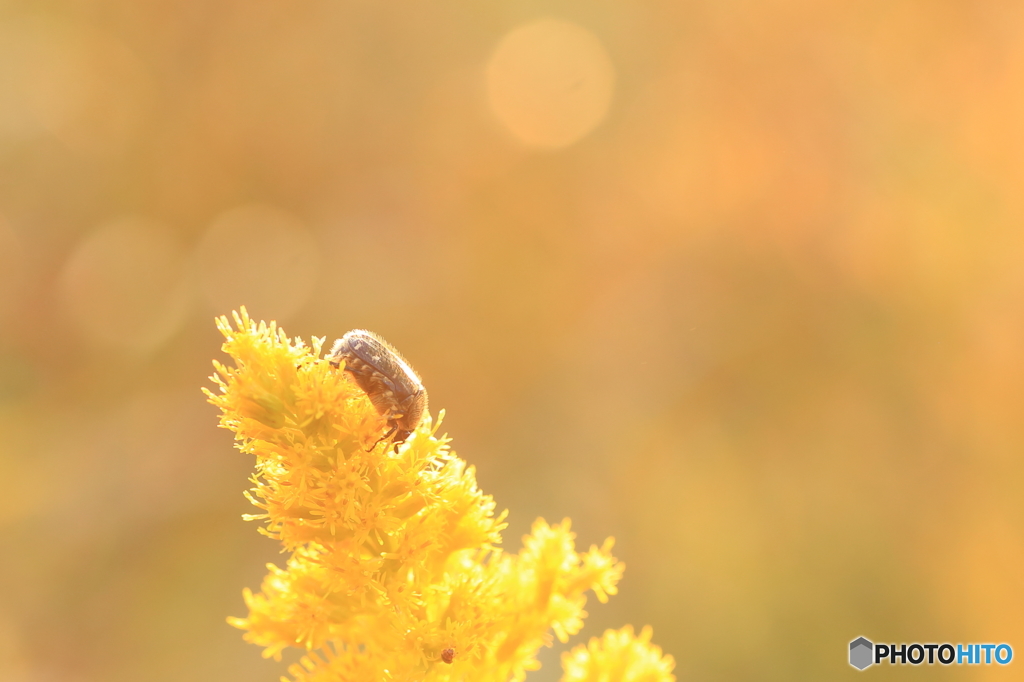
[[59, 218, 189, 351]]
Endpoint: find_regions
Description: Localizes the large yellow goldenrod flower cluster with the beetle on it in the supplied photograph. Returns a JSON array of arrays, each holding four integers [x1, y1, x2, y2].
[[206, 308, 671, 682]]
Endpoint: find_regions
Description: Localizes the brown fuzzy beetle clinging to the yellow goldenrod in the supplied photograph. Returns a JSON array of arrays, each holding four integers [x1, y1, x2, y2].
[[330, 329, 427, 449]]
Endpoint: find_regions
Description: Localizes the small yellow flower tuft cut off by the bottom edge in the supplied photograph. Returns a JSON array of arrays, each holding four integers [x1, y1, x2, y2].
[[561, 626, 676, 682]]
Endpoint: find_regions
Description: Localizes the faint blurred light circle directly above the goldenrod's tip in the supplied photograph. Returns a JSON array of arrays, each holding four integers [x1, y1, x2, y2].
[[198, 204, 321, 319]]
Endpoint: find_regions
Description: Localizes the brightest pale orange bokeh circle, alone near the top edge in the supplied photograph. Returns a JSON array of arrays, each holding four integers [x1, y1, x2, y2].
[[486, 18, 614, 147]]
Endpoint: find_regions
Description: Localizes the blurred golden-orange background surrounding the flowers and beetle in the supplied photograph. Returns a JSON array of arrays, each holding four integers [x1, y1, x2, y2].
[[0, 0, 1024, 682]]
